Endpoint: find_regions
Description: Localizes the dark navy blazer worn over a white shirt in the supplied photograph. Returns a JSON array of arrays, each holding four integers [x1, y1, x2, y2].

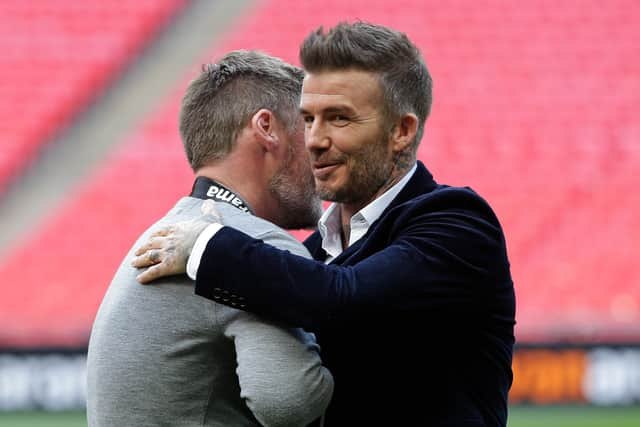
[[196, 162, 515, 427]]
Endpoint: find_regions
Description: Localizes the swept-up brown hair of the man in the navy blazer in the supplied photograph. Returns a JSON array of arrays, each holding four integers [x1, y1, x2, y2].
[[300, 21, 433, 150]]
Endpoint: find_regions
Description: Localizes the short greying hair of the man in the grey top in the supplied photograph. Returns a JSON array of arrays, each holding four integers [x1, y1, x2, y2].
[[180, 50, 304, 171]]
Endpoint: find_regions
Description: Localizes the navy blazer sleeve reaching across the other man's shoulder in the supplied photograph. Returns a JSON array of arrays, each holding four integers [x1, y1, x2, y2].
[[196, 201, 510, 330]]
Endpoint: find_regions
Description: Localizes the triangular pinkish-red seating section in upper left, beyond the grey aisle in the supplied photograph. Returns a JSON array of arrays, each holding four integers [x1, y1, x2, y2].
[[0, 0, 185, 191]]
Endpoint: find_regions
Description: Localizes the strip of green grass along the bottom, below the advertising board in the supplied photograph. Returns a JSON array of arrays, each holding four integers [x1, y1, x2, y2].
[[0, 406, 640, 427]]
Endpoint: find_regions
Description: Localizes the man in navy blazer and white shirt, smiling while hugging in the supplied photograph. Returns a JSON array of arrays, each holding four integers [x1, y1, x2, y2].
[[136, 22, 515, 427]]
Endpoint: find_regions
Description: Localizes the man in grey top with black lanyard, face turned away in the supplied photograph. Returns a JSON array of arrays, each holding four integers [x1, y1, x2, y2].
[[87, 51, 333, 427]]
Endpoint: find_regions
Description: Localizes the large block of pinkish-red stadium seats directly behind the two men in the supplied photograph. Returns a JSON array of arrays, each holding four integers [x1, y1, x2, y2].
[[0, 0, 640, 345]]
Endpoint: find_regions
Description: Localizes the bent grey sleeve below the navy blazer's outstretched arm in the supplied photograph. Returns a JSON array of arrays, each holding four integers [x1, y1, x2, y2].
[[225, 311, 333, 427]]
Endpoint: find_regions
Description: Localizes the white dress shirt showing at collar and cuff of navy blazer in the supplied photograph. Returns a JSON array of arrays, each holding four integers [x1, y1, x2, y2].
[[187, 164, 417, 280]]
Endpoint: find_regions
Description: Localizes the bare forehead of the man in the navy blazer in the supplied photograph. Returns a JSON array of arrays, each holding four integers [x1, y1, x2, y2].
[[301, 69, 382, 110]]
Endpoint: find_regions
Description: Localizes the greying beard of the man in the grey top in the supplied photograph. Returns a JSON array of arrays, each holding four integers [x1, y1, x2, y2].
[[269, 145, 322, 230]]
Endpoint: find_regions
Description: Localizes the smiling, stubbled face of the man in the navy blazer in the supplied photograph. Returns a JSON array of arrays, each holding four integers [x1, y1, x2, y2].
[[301, 70, 393, 217]]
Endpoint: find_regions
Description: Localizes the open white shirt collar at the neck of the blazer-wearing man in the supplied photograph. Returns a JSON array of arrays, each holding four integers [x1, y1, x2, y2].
[[318, 164, 417, 262]]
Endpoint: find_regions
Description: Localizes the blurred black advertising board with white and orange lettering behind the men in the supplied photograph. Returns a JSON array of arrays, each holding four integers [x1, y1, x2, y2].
[[0, 345, 640, 411]]
